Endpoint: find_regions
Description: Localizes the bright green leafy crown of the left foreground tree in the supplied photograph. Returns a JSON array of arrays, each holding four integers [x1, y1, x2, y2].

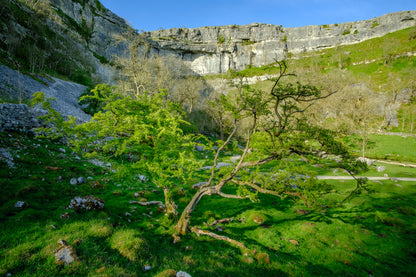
[[72, 85, 197, 190]]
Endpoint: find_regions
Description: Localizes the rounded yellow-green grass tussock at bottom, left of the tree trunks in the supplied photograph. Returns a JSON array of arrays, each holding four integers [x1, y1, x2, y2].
[[110, 229, 148, 261]]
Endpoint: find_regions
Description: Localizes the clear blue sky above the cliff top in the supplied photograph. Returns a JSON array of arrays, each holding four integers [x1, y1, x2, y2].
[[101, 0, 416, 31]]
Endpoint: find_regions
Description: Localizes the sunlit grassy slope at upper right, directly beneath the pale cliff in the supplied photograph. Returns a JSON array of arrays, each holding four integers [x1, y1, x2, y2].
[[218, 27, 416, 133]]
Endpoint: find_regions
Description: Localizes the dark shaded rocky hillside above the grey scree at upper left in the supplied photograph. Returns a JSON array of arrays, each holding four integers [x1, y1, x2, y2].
[[0, 0, 128, 85]]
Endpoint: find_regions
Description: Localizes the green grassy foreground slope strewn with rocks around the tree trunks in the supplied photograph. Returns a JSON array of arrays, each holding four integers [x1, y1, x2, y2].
[[0, 133, 416, 276]]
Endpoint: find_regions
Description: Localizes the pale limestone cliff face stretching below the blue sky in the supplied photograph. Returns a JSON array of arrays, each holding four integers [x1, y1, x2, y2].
[[145, 11, 416, 75]]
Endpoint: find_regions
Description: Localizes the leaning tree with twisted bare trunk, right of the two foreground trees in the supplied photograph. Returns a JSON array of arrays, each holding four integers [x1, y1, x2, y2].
[[175, 62, 364, 246]]
